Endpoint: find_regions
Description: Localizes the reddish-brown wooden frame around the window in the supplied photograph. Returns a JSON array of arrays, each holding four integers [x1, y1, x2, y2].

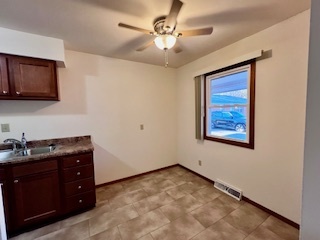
[[203, 59, 256, 149]]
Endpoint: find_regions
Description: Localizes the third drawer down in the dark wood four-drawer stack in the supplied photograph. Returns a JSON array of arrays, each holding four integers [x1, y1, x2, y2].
[[64, 177, 95, 197]]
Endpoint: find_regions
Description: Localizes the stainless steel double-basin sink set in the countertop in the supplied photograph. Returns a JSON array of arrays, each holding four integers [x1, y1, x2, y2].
[[0, 146, 56, 161]]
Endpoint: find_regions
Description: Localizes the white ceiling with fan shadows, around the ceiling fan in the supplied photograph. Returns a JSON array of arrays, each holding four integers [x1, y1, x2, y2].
[[0, 0, 311, 67]]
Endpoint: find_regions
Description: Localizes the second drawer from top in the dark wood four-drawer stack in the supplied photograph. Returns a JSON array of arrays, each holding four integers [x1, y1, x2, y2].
[[63, 165, 93, 182]]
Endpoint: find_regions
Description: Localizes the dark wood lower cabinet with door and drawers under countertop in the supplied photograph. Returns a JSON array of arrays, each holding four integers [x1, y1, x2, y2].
[[0, 152, 96, 235]]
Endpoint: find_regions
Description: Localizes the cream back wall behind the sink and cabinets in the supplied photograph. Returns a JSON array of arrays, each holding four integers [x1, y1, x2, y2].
[[0, 51, 177, 184]]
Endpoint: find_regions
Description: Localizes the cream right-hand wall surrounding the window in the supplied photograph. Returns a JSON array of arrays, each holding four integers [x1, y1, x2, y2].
[[177, 11, 310, 223]]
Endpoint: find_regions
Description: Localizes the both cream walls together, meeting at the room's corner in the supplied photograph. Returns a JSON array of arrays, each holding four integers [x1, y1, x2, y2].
[[0, 11, 310, 226]]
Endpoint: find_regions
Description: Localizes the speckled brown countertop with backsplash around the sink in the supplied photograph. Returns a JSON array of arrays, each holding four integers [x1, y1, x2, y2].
[[0, 136, 94, 165]]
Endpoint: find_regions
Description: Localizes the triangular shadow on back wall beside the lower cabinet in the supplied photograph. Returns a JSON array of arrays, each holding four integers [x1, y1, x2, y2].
[[93, 142, 139, 185]]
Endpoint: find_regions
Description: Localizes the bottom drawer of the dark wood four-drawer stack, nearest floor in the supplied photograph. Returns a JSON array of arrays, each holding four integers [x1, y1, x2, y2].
[[65, 191, 96, 213]]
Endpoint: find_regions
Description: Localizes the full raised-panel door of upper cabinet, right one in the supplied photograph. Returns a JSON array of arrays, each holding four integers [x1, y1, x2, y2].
[[10, 57, 58, 100]]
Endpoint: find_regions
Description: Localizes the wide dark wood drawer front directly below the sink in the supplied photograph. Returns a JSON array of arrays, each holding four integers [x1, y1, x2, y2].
[[12, 160, 58, 178]]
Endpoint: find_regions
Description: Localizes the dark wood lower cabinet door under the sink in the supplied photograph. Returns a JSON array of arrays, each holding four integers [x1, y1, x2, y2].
[[14, 171, 60, 227]]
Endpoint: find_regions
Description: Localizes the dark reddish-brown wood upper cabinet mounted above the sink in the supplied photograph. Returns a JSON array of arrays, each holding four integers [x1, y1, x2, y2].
[[0, 55, 59, 100]]
